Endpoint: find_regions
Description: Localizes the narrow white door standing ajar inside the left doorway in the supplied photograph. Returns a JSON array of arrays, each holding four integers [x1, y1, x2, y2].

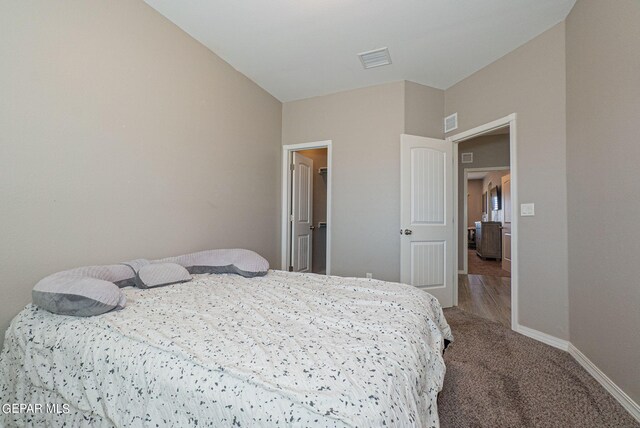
[[290, 152, 314, 272]]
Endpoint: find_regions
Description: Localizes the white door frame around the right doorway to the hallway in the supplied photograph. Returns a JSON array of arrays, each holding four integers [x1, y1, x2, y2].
[[447, 113, 520, 331]]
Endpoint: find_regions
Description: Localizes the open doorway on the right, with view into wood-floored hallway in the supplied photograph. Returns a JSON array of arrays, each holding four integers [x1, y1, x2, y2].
[[451, 115, 517, 328]]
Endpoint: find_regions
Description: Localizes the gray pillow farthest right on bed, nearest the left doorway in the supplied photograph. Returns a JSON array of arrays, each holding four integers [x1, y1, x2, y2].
[[159, 249, 269, 278]]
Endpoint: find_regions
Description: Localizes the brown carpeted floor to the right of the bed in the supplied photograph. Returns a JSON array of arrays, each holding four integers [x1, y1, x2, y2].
[[438, 308, 640, 428]]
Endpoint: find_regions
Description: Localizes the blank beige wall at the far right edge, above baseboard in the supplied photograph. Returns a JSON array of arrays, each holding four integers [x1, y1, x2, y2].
[[566, 0, 640, 403]]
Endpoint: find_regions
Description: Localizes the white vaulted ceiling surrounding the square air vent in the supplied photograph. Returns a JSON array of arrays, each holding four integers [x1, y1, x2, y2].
[[145, 0, 576, 102]]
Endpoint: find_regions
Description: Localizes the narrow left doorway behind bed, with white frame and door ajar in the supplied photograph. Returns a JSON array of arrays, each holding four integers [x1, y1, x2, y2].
[[282, 141, 331, 275]]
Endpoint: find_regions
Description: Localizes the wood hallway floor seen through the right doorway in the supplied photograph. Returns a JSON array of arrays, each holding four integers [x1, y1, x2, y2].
[[458, 275, 511, 329]]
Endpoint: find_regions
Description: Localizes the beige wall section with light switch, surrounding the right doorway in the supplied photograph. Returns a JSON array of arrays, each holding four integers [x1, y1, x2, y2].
[[445, 23, 569, 339]]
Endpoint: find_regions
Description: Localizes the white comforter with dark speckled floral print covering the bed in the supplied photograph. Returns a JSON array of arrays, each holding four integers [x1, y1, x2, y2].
[[0, 271, 452, 427]]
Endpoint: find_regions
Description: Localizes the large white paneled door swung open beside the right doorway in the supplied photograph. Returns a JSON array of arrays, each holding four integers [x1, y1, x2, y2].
[[400, 135, 454, 307]]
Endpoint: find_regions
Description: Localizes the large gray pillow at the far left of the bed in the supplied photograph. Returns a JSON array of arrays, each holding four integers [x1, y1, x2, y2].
[[32, 274, 127, 317]]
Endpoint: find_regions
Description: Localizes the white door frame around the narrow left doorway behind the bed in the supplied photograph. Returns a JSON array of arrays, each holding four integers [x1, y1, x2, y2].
[[280, 140, 333, 275]]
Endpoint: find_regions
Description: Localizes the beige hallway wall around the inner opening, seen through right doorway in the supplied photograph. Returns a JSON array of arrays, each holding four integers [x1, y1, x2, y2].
[[458, 134, 509, 270]]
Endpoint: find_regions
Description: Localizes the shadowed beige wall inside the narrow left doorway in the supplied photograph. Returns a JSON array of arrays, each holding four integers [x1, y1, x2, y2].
[[298, 149, 327, 273]]
